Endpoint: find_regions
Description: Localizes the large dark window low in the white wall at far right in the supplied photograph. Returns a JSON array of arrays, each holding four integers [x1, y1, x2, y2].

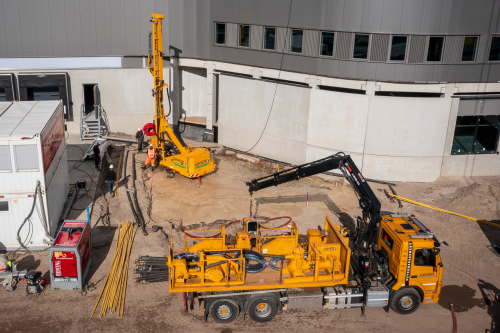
[[451, 115, 500, 155]]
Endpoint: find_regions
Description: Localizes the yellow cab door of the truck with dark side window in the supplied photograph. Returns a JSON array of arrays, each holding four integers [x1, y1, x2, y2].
[[410, 247, 441, 303]]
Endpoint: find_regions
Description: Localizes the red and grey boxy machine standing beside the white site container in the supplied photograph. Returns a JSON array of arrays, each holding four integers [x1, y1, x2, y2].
[[50, 221, 92, 290]]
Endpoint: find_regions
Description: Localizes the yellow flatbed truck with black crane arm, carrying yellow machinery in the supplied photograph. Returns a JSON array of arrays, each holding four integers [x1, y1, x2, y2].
[[167, 153, 443, 323]]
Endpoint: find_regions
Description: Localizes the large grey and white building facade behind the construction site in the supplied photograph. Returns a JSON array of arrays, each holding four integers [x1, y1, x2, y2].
[[0, 0, 500, 181]]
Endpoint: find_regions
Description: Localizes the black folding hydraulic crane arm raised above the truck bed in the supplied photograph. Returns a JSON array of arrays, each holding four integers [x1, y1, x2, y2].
[[246, 153, 381, 217]]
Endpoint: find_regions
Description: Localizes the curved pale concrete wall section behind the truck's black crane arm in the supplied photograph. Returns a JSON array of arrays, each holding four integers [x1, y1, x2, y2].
[[219, 75, 480, 182]]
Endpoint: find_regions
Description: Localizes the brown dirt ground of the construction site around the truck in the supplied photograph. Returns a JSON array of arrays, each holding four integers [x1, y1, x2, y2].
[[0, 140, 500, 333]]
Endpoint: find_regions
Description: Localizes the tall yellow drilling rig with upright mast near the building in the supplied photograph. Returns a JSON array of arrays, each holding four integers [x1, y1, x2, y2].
[[148, 13, 217, 178]]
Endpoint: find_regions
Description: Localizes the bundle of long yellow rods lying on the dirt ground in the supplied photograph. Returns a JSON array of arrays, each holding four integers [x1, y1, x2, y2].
[[91, 221, 137, 317]]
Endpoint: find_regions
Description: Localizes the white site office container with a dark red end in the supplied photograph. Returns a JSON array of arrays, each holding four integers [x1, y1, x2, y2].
[[0, 101, 69, 250]]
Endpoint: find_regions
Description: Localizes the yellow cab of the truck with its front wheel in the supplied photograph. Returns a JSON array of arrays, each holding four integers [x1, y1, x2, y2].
[[376, 213, 443, 314]]
